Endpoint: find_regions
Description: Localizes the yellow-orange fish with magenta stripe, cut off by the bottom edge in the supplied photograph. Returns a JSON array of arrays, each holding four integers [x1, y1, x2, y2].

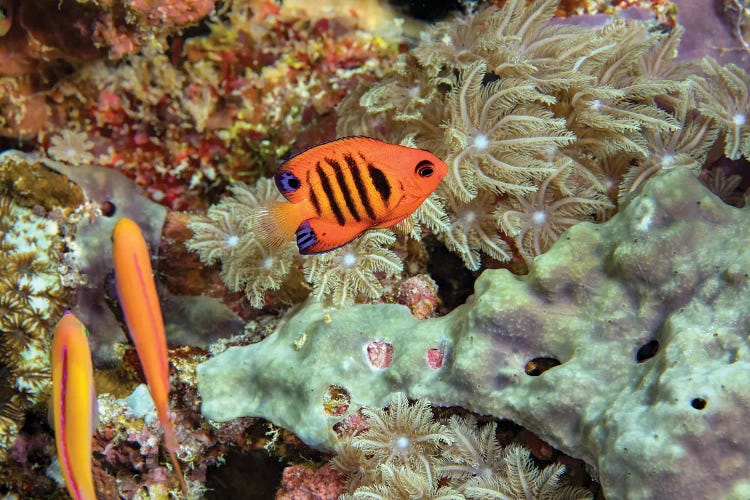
[[52, 311, 96, 500]]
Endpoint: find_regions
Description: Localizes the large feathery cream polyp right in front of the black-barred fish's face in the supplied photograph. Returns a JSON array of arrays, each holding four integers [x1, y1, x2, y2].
[[446, 62, 574, 202]]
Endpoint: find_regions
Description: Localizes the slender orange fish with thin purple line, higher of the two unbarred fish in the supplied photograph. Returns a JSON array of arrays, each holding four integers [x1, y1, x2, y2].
[[112, 218, 187, 492]]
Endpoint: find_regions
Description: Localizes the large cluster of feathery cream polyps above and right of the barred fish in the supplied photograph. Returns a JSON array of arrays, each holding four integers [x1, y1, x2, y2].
[[337, 0, 749, 270]]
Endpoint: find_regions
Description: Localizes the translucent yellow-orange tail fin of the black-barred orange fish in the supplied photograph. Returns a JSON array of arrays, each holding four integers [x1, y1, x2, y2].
[[252, 201, 305, 248]]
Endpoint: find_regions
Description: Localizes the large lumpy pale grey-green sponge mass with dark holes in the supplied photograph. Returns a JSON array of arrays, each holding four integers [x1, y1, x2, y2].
[[197, 168, 750, 499]]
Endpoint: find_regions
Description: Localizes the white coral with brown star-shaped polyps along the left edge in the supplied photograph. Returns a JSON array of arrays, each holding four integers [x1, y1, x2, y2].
[[0, 154, 82, 462]]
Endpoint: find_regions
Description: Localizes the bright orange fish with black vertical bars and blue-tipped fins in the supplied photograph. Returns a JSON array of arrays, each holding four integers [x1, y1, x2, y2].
[[254, 137, 448, 254]]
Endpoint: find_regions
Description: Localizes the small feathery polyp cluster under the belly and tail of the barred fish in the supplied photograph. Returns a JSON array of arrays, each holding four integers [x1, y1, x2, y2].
[[187, 178, 418, 307]]
